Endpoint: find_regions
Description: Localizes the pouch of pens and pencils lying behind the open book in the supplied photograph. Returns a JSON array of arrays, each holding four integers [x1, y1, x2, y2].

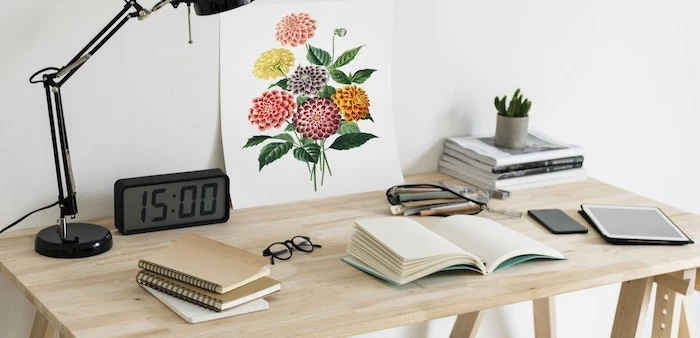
[[386, 183, 522, 218]]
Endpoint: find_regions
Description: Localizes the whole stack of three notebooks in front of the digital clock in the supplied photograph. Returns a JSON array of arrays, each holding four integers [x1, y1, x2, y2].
[[136, 234, 281, 323]]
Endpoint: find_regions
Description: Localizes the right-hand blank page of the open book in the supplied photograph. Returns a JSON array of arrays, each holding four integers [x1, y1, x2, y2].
[[431, 215, 565, 273]]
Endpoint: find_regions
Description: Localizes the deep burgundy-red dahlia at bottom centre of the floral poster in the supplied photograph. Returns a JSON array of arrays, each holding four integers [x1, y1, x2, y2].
[[292, 97, 340, 140]]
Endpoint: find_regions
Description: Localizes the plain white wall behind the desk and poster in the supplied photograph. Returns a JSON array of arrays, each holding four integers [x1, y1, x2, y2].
[[0, 0, 700, 337]]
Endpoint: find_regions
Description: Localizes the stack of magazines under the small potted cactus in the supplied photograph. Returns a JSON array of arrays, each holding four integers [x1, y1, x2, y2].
[[438, 132, 586, 191]]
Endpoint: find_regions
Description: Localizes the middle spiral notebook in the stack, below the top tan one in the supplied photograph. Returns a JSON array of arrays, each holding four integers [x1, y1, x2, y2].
[[136, 270, 281, 311]]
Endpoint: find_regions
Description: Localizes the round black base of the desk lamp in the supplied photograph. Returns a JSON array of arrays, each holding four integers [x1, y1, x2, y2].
[[34, 223, 112, 258]]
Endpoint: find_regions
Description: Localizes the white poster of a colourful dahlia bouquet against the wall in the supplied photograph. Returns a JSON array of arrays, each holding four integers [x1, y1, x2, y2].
[[221, 0, 402, 208]]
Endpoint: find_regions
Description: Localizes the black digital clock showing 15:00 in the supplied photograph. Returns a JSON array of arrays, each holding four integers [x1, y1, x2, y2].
[[114, 169, 229, 235]]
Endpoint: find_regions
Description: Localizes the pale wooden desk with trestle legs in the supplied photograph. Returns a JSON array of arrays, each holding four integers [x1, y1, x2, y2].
[[0, 174, 700, 337]]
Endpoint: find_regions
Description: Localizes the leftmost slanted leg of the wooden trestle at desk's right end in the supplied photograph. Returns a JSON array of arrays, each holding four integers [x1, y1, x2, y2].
[[610, 277, 654, 338]]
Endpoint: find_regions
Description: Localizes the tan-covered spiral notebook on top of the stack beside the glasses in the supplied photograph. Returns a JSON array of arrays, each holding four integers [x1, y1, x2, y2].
[[139, 233, 270, 293]]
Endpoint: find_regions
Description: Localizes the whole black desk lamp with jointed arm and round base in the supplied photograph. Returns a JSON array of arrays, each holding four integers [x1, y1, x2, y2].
[[29, 0, 253, 258]]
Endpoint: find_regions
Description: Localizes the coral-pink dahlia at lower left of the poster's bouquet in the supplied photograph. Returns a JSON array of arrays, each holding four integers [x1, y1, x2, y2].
[[248, 90, 296, 131]]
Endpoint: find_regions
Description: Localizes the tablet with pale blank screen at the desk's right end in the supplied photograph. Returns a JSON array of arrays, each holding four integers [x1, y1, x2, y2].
[[581, 204, 693, 243]]
